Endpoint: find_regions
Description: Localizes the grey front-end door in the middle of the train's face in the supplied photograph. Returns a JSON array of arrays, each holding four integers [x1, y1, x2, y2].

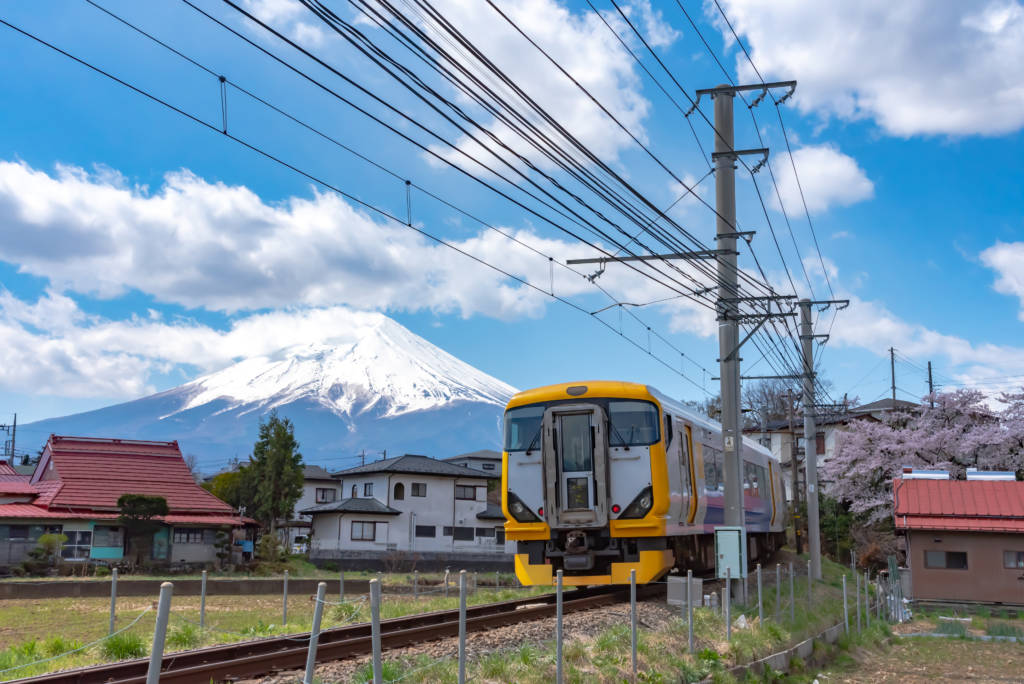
[[544, 404, 607, 527]]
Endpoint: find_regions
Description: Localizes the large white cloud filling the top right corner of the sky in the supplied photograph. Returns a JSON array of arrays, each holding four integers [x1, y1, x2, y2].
[[708, 0, 1024, 136]]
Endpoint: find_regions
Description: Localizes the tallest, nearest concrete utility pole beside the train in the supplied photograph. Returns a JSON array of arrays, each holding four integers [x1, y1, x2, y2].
[[713, 86, 743, 552]]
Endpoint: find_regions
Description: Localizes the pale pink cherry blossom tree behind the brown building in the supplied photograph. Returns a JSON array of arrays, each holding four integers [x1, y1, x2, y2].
[[821, 389, 1024, 523]]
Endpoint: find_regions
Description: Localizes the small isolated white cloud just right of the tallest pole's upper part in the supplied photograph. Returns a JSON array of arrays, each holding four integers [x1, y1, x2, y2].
[[771, 144, 874, 215]]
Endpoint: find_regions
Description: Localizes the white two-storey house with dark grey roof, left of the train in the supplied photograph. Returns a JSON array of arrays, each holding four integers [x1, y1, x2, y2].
[[300, 455, 512, 568]]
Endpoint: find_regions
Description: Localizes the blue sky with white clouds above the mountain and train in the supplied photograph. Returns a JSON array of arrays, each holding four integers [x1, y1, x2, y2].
[[0, 0, 1024, 438]]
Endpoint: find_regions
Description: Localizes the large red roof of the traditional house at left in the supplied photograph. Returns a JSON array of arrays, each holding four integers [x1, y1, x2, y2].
[[43, 436, 232, 516]]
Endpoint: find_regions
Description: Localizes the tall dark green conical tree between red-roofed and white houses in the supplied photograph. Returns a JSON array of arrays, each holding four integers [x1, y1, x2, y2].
[[245, 411, 303, 533]]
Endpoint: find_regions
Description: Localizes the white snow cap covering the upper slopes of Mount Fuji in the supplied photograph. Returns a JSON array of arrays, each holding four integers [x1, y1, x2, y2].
[[175, 315, 516, 417]]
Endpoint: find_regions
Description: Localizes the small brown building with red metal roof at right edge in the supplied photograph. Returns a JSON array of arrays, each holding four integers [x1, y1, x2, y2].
[[893, 470, 1024, 605]]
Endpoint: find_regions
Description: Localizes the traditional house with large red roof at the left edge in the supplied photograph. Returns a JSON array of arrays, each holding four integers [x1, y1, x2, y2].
[[0, 435, 252, 567]]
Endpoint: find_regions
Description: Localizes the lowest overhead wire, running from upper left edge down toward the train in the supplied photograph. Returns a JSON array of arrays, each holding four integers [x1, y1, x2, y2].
[[0, 12, 707, 392]]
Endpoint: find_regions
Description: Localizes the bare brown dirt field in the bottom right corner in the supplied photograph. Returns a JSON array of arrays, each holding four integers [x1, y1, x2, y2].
[[816, 638, 1024, 684]]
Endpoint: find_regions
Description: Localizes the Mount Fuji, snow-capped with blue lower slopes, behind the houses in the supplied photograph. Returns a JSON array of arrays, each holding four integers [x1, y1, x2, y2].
[[27, 314, 516, 473]]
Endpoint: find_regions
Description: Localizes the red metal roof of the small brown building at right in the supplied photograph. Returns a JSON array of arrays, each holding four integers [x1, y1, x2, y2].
[[893, 478, 1024, 533]]
